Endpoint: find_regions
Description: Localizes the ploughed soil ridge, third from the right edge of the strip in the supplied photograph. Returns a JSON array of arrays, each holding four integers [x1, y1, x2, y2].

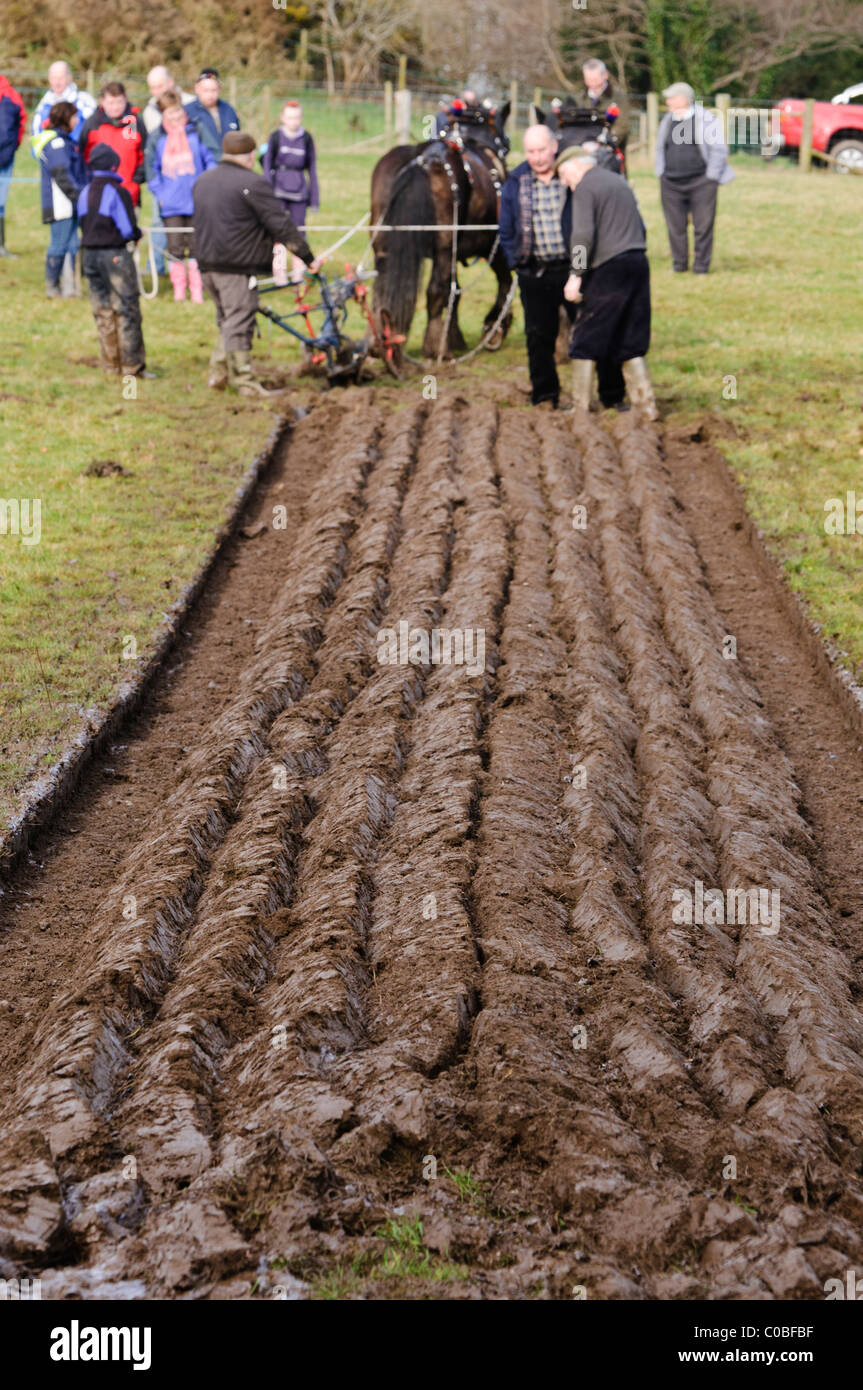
[[543, 419, 713, 1172]]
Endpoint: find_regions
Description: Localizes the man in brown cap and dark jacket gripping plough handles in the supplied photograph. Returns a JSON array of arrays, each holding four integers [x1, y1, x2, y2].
[[193, 131, 318, 396]]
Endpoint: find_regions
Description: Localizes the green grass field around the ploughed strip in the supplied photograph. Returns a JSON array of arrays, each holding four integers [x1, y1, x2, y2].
[[0, 97, 863, 824]]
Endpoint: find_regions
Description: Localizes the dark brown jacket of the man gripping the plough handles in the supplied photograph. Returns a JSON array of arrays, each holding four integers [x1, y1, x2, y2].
[[193, 158, 314, 275]]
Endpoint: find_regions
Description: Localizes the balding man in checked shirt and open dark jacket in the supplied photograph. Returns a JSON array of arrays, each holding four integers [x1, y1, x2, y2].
[[500, 125, 575, 410]]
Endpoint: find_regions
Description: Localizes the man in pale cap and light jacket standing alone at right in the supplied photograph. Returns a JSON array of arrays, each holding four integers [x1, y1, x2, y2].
[[655, 82, 734, 275]]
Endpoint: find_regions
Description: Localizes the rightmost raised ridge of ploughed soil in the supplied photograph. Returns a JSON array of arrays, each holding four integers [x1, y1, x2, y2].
[[621, 417, 863, 1155]]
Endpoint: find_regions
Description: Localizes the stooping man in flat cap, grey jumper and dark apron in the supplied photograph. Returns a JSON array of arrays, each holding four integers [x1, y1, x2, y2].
[[557, 146, 656, 420]]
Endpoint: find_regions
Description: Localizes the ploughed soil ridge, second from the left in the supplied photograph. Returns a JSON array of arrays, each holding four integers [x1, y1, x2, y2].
[[106, 410, 421, 1193]]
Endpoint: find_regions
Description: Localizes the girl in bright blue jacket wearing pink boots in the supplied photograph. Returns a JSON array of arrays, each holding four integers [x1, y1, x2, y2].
[[150, 92, 215, 304]]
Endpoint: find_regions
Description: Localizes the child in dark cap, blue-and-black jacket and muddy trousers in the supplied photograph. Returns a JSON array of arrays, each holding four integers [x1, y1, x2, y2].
[[78, 145, 153, 378]]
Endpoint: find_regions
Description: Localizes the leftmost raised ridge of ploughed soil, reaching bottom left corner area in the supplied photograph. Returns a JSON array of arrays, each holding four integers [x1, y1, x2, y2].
[[0, 409, 379, 1252]]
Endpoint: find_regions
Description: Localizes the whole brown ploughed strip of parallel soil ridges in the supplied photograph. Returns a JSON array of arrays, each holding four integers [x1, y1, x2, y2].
[[0, 388, 863, 1298]]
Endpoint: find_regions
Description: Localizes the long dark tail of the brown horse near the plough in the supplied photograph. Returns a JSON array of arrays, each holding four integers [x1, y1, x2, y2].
[[375, 160, 438, 334]]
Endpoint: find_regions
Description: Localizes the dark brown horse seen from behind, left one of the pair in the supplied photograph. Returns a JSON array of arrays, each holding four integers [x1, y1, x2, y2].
[[371, 104, 513, 359]]
